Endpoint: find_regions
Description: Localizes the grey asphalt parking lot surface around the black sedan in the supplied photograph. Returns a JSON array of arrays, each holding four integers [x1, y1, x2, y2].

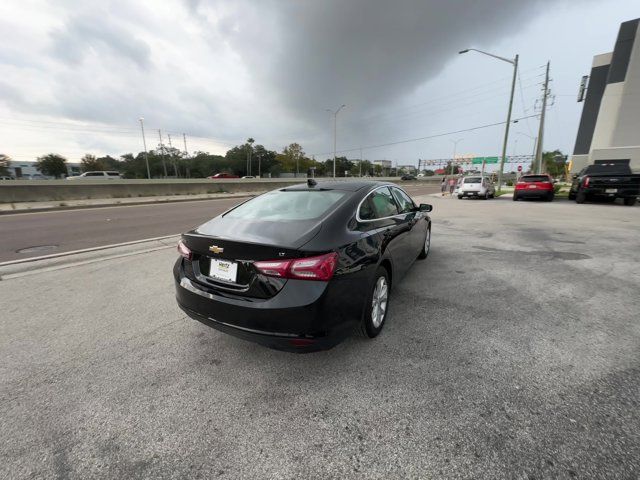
[[0, 196, 640, 479]]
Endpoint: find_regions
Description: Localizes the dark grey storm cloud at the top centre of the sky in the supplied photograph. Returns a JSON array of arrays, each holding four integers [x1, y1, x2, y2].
[[195, 0, 555, 129]]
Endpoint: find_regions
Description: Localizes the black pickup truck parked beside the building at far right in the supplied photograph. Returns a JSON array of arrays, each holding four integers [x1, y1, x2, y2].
[[569, 160, 640, 205]]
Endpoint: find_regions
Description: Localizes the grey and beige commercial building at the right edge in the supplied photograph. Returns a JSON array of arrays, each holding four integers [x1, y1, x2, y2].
[[571, 18, 640, 173]]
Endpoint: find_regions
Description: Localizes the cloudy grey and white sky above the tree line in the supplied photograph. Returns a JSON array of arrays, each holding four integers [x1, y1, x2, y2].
[[0, 0, 640, 164]]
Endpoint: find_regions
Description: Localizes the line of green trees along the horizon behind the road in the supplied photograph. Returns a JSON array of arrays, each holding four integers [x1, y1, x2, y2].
[[7, 138, 388, 179]]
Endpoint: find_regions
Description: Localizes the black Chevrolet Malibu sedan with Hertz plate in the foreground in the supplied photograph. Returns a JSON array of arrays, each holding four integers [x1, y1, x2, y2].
[[173, 180, 431, 351]]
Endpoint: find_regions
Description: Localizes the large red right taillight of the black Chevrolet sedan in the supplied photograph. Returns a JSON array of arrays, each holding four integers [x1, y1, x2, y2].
[[253, 252, 338, 281]]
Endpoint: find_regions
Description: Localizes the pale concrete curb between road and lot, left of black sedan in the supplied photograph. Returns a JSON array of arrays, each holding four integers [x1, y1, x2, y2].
[[0, 234, 180, 281]]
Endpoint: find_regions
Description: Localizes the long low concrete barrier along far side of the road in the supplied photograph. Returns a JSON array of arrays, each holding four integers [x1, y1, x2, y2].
[[0, 178, 444, 203]]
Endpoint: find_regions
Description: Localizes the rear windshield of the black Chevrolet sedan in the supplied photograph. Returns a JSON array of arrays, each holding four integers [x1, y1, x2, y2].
[[224, 190, 346, 221]]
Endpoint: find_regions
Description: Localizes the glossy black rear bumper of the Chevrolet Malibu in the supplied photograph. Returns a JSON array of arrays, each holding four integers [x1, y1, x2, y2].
[[174, 259, 353, 352]]
